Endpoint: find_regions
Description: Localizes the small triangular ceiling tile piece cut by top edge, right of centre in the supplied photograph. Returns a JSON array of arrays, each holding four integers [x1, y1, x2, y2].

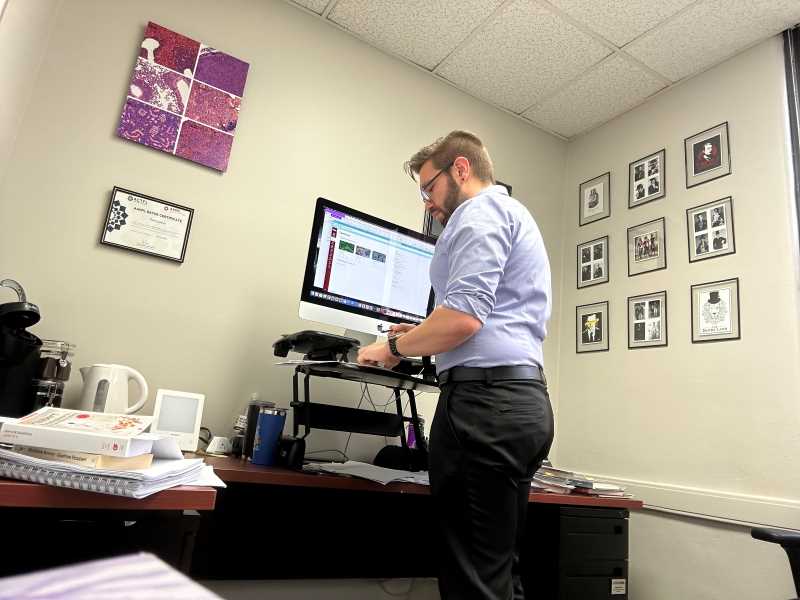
[[550, 0, 695, 47]]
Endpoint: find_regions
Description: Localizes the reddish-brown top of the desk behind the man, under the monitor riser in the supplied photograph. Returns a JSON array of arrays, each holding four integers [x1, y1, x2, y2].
[[204, 456, 642, 509]]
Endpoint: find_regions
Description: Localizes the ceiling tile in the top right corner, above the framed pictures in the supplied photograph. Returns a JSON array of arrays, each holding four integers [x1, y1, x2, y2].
[[625, 0, 800, 81]]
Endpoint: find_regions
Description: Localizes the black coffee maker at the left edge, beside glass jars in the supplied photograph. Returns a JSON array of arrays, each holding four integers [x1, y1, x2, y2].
[[0, 279, 42, 417]]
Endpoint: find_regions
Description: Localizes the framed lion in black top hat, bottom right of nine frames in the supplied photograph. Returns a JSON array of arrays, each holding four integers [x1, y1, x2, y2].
[[691, 277, 741, 344]]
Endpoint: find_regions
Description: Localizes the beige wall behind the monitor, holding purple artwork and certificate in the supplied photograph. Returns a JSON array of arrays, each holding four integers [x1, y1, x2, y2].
[[0, 0, 566, 459]]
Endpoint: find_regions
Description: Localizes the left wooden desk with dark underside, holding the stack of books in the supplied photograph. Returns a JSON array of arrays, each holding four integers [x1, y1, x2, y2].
[[0, 479, 217, 576]]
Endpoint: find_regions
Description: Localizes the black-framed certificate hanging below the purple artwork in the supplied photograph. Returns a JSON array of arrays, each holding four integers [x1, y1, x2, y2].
[[100, 186, 194, 263]]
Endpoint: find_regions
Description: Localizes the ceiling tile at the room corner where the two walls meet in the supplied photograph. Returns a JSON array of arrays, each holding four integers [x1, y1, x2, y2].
[[522, 55, 665, 137]]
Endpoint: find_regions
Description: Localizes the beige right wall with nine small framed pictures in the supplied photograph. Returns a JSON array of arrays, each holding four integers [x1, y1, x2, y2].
[[558, 37, 800, 600]]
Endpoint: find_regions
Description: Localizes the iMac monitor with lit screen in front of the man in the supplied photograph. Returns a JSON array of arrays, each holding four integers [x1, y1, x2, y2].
[[300, 198, 435, 335]]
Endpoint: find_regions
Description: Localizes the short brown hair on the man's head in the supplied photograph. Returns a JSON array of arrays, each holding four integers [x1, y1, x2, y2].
[[403, 130, 495, 183]]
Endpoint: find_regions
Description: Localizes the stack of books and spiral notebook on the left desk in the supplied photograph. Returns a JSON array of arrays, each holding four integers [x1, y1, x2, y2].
[[0, 407, 222, 498]]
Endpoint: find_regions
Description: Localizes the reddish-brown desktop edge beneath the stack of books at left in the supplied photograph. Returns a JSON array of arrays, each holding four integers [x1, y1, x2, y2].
[[0, 479, 217, 510]]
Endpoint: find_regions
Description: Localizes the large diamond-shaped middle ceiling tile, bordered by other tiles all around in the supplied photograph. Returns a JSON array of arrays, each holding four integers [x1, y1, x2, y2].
[[436, 0, 611, 113]]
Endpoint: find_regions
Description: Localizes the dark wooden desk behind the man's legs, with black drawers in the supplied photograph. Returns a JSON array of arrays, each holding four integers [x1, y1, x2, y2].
[[191, 457, 642, 600]]
